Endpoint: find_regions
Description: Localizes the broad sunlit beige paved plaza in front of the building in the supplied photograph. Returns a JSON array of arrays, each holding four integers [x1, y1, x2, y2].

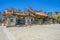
[[8, 24, 60, 40]]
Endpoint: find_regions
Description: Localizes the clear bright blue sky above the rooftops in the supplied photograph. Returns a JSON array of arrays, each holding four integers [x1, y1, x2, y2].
[[0, 0, 60, 12]]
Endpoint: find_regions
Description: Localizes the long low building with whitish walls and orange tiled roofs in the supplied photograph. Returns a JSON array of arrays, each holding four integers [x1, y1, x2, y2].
[[3, 8, 51, 26]]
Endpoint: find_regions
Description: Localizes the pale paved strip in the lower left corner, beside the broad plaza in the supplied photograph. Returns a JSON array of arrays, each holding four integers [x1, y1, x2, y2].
[[0, 26, 16, 40]]
